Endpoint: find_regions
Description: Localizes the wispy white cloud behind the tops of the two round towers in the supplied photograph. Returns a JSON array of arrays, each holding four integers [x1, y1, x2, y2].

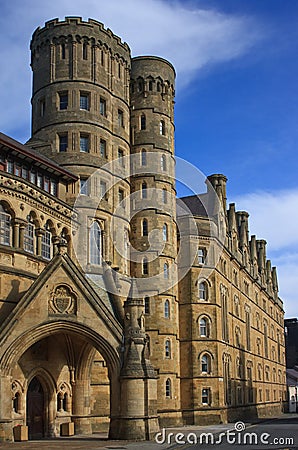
[[0, 0, 261, 137]]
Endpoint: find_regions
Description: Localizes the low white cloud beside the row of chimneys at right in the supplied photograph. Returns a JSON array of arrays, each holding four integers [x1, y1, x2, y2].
[[235, 189, 298, 317]]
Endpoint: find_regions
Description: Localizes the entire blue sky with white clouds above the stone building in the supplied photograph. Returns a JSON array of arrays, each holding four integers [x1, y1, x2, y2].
[[0, 0, 298, 317]]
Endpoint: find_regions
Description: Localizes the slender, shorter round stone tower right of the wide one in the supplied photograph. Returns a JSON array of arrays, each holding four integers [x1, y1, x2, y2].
[[130, 56, 180, 425]]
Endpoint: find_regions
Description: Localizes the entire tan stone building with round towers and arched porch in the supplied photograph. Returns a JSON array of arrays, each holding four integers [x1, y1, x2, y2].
[[0, 17, 285, 440]]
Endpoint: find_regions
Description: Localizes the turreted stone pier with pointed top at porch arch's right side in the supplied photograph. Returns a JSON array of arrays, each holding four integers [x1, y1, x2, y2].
[[118, 281, 159, 440]]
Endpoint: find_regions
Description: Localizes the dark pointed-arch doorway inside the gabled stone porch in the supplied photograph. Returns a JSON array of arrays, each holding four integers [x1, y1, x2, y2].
[[26, 377, 45, 439]]
